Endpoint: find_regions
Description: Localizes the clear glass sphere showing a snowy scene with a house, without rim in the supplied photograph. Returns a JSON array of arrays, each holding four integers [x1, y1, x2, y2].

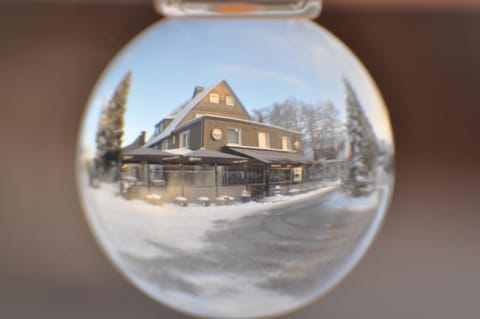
[[77, 19, 394, 318]]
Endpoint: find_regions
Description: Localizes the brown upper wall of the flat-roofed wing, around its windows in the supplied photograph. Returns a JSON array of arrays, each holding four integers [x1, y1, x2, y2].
[[203, 118, 303, 153]]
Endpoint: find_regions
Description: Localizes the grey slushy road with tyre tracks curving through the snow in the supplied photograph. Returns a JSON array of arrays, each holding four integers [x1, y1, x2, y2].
[[117, 191, 375, 318]]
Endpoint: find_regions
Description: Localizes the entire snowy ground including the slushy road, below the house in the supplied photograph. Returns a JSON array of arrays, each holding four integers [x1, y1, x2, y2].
[[80, 179, 381, 317]]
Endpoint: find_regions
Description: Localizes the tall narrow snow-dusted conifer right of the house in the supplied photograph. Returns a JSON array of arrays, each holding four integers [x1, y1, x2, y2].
[[343, 80, 378, 196]]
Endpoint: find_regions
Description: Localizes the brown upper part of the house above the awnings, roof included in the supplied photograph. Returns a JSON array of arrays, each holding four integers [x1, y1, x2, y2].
[[147, 81, 303, 154]]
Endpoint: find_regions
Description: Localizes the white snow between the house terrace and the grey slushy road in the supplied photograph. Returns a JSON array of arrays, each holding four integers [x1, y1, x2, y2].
[[82, 176, 336, 258]]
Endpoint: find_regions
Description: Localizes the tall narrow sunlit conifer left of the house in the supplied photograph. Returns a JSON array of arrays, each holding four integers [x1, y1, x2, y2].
[[96, 71, 132, 178]]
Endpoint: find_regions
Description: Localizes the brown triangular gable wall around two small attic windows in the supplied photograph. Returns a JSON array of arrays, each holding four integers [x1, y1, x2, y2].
[[179, 82, 250, 126]]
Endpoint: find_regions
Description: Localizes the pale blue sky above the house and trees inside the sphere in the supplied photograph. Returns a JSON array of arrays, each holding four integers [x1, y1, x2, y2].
[[80, 19, 392, 154]]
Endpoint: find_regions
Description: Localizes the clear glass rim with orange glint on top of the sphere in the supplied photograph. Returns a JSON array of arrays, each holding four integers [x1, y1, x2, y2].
[[153, 0, 322, 19]]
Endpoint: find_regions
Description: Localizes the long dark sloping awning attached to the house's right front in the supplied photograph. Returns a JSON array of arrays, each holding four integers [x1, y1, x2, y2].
[[224, 146, 312, 165]]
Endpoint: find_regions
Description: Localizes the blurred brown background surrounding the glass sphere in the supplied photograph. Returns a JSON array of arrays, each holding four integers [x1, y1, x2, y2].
[[0, 0, 480, 319]]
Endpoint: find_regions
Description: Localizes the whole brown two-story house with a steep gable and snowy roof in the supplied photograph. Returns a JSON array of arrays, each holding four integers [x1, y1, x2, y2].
[[124, 81, 310, 197]]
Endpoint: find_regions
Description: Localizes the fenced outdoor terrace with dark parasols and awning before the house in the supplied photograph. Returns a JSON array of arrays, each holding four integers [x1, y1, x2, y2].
[[120, 147, 328, 207]]
